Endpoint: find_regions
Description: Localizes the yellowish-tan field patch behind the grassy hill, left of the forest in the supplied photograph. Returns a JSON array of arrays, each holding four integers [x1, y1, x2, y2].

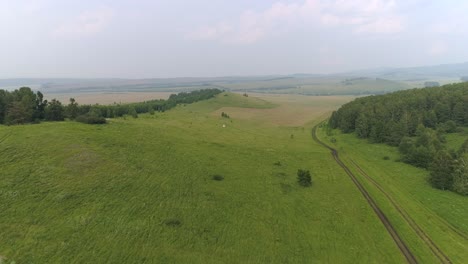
[[213, 94, 354, 126]]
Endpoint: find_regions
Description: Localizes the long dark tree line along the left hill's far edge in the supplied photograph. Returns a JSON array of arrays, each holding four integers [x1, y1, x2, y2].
[[0, 87, 222, 125]]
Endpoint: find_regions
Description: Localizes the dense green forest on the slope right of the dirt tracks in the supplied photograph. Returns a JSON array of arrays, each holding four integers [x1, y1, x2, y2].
[[329, 83, 468, 195]]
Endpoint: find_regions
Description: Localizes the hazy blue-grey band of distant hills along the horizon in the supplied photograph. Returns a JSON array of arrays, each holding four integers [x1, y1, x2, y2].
[[0, 62, 468, 95]]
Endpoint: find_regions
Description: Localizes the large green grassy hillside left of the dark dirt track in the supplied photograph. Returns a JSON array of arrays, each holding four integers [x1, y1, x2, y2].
[[0, 94, 404, 263]]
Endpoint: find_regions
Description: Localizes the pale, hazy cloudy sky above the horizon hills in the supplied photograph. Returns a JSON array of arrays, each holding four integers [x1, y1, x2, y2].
[[0, 0, 468, 78]]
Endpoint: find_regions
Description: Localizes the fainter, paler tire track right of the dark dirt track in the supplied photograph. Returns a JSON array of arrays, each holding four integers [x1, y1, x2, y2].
[[351, 159, 452, 263]]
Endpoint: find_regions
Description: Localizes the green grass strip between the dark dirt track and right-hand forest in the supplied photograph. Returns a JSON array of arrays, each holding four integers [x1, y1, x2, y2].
[[321, 127, 468, 263]]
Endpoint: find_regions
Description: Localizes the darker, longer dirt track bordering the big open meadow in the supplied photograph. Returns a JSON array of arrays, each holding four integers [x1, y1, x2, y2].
[[312, 124, 418, 264]]
